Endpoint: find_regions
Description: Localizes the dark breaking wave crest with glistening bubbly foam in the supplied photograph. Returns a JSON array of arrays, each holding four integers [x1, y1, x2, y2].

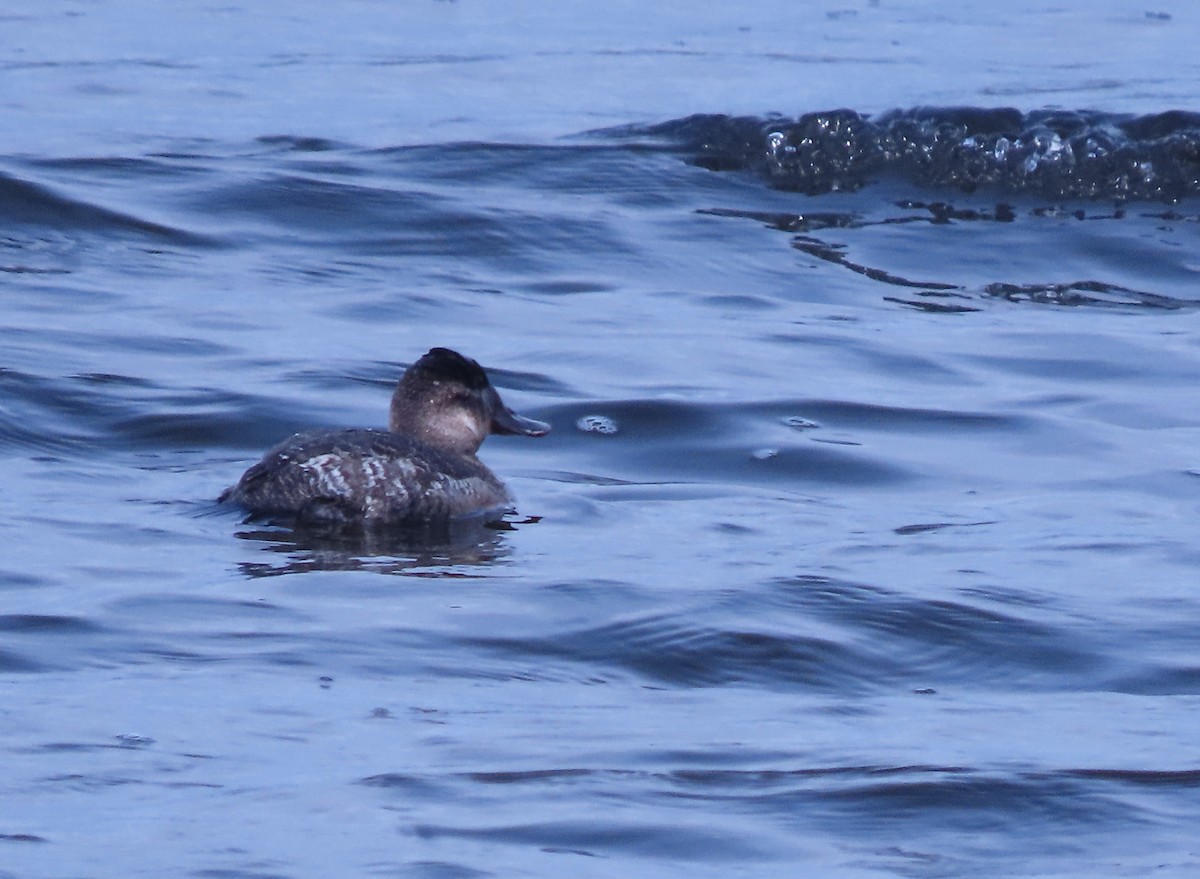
[[611, 107, 1200, 202]]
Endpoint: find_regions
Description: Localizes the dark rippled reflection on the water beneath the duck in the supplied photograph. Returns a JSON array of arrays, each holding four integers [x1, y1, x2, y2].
[[236, 518, 538, 578]]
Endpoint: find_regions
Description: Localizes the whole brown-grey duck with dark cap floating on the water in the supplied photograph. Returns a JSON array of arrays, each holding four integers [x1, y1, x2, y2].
[[217, 348, 550, 530]]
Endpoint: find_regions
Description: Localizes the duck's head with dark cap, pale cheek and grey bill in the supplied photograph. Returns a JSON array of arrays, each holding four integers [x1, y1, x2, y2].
[[388, 348, 550, 455]]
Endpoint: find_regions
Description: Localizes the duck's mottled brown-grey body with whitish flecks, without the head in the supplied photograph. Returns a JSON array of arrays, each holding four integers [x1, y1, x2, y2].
[[220, 430, 511, 527]]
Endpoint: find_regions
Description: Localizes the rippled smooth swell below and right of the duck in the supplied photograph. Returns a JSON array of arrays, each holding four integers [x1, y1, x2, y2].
[[436, 575, 1109, 693]]
